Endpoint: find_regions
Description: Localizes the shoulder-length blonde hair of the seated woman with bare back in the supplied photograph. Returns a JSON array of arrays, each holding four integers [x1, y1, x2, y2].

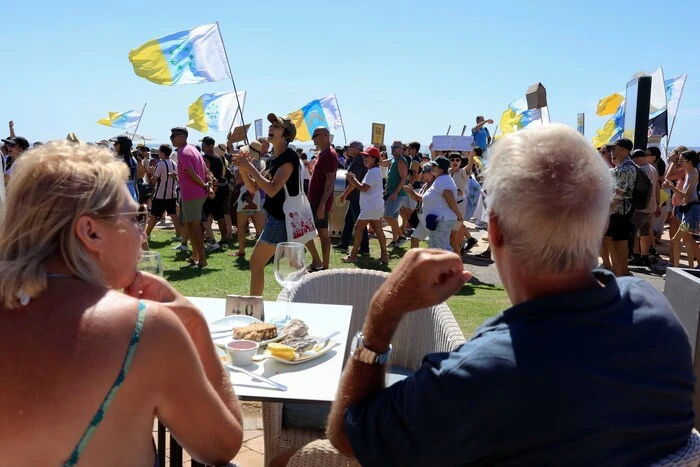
[[0, 140, 129, 308]]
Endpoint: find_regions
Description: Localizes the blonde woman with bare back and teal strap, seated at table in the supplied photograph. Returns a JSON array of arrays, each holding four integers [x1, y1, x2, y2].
[[0, 141, 243, 467]]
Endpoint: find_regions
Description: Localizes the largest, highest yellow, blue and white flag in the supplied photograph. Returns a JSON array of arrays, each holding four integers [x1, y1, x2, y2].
[[129, 23, 231, 86]]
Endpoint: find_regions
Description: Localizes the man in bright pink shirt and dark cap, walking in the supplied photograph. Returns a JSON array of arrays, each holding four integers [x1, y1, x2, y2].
[[170, 127, 214, 268]]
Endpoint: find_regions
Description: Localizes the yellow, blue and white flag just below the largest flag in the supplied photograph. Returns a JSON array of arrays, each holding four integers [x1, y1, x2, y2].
[[187, 91, 246, 133]]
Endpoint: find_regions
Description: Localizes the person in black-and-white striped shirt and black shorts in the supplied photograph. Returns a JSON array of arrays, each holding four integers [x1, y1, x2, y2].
[[146, 144, 181, 241]]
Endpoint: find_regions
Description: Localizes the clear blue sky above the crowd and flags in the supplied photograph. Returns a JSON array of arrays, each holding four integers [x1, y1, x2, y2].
[[0, 0, 700, 146]]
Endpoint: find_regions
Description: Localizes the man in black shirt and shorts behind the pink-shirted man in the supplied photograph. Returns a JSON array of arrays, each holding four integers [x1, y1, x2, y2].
[[202, 136, 230, 251]]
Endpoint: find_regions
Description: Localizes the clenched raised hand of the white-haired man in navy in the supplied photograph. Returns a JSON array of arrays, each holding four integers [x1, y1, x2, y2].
[[370, 248, 472, 317]]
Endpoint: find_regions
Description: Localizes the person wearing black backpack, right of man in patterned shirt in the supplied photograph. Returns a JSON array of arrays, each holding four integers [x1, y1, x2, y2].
[[630, 149, 661, 268]]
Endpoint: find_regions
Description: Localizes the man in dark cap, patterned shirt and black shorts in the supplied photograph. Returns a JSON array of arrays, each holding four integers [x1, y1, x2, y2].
[[605, 138, 637, 277]]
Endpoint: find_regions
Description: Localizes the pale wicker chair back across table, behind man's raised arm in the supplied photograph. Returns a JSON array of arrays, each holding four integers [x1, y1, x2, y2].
[[288, 269, 464, 370]]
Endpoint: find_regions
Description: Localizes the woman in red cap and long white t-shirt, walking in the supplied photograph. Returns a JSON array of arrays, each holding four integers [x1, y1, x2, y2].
[[341, 147, 389, 264]]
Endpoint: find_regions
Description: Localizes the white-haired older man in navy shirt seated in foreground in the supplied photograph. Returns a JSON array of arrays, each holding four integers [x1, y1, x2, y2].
[[328, 125, 694, 466]]
